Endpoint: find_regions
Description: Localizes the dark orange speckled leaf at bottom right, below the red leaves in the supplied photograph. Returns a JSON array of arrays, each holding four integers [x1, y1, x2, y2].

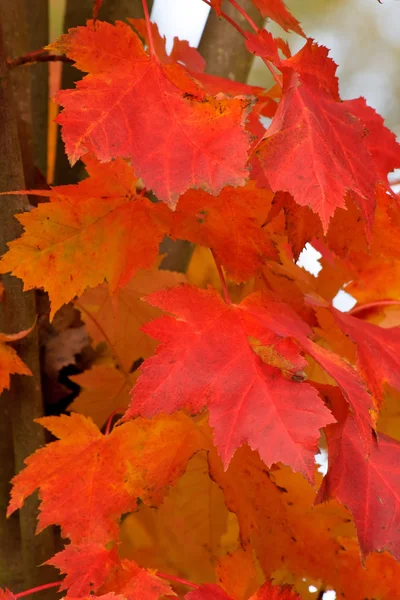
[[209, 438, 400, 600]]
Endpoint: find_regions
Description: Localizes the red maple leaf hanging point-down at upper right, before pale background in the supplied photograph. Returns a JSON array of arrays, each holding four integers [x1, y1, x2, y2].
[[257, 40, 380, 233]]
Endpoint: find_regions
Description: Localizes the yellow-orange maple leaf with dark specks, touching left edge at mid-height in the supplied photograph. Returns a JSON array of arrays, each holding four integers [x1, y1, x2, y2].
[[0, 158, 167, 316]]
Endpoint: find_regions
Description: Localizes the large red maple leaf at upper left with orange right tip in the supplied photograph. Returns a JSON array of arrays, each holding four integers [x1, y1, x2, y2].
[[50, 21, 251, 207]]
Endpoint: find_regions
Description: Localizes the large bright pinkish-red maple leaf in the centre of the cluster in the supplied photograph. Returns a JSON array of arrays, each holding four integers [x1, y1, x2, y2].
[[125, 285, 332, 480]]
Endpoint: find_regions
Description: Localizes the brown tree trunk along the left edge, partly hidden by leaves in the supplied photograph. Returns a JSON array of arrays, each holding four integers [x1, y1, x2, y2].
[[0, 0, 53, 598]]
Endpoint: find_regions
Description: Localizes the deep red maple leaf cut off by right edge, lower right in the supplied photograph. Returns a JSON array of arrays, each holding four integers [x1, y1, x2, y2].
[[316, 395, 400, 560]]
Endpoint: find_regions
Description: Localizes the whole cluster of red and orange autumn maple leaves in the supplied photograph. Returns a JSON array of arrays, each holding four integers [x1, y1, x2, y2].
[[0, 0, 400, 600]]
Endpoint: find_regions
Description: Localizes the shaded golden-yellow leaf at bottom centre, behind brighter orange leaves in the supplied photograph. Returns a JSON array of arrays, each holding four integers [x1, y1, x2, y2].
[[120, 452, 238, 583]]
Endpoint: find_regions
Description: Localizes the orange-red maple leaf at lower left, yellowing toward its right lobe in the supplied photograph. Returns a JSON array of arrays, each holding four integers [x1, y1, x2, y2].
[[8, 414, 203, 543]]
